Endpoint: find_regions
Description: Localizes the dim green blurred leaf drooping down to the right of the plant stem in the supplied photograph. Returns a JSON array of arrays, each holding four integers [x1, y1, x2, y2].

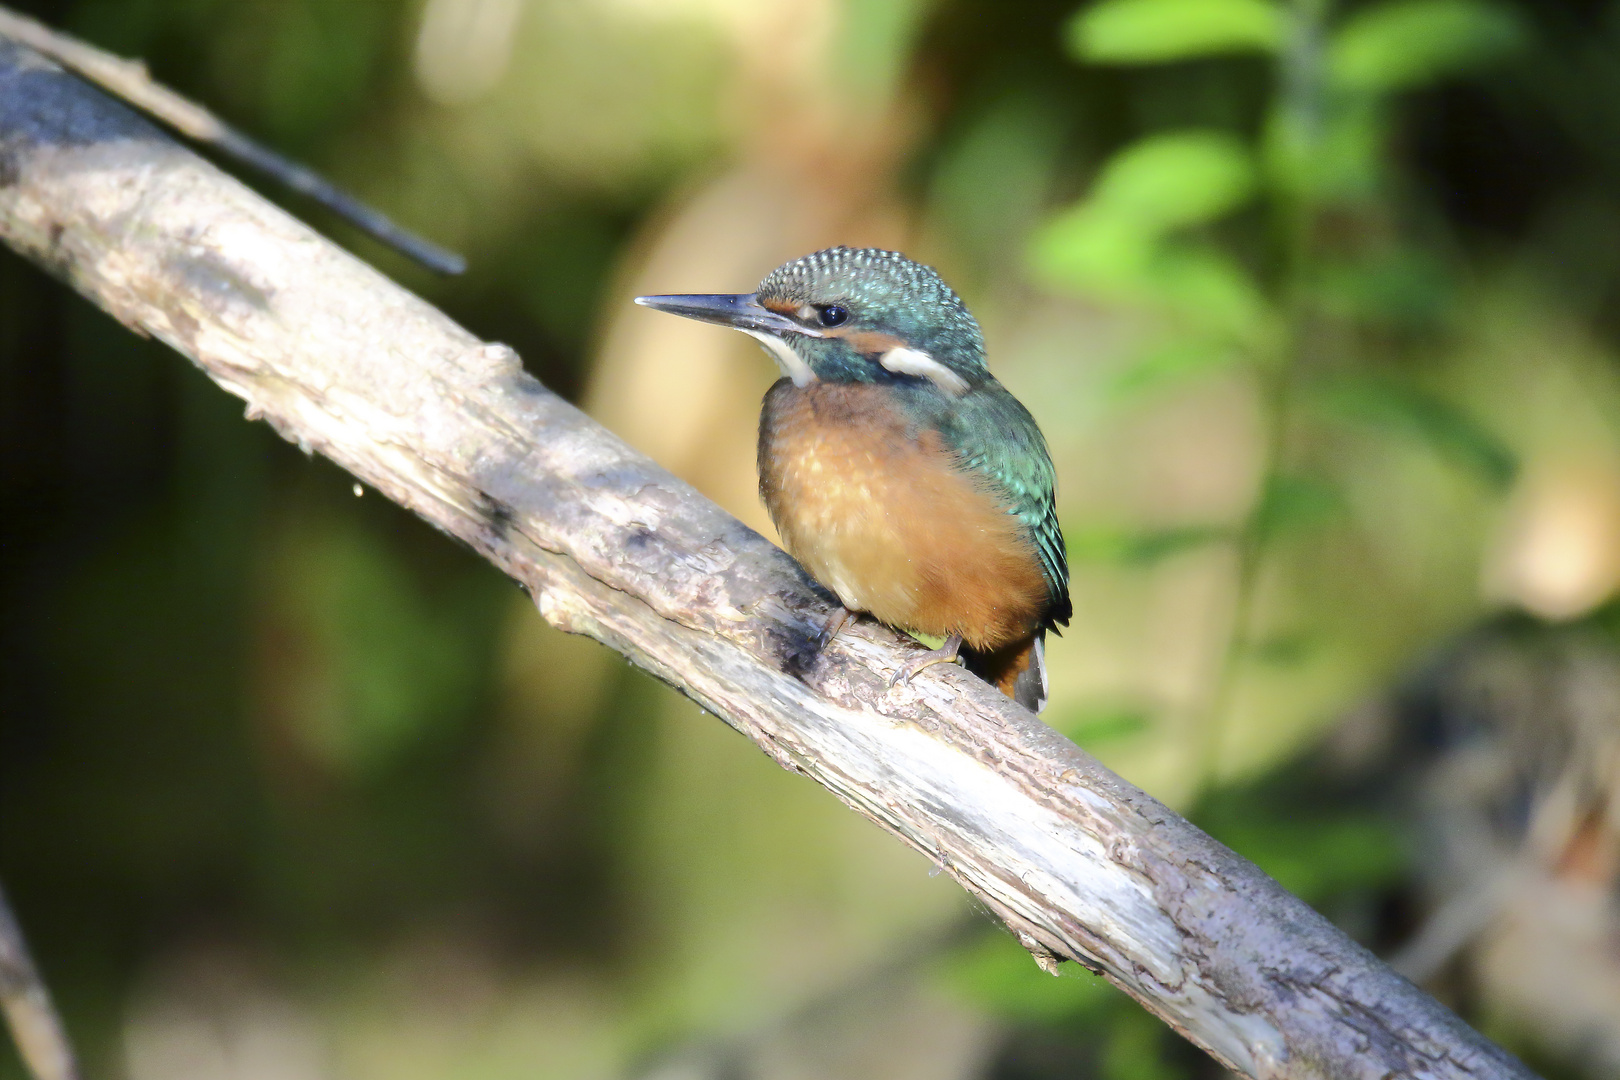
[[1320, 379, 1518, 491]]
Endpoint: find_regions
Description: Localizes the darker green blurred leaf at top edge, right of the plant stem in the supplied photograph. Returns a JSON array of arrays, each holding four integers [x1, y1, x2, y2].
[[1328, 0, 1526, 94]]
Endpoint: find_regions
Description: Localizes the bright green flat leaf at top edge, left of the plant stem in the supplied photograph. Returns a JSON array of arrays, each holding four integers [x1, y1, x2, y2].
[[1068, 0, 1283, 63]]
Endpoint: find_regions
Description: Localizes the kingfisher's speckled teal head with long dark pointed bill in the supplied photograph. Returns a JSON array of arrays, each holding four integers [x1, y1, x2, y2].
[[635, 248, 990, 397]]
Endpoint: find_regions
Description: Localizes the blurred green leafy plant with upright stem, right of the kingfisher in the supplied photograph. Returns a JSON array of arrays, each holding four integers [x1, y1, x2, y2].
[[1029, 0, 1528, 809]]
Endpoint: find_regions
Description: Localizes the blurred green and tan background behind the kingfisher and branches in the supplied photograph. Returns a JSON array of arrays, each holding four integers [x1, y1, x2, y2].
[[0, 0, 1620, 1080]]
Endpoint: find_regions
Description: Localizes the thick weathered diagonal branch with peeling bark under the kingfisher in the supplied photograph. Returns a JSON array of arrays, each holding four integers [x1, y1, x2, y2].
[[0, 40, 1531, 1078]]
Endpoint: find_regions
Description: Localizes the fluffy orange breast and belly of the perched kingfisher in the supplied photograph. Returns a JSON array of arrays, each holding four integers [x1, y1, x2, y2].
[[760, 379, 1047, 649]]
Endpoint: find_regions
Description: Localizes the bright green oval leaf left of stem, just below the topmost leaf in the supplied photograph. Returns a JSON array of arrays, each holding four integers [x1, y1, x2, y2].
[[1087, 128, 1256, 232]]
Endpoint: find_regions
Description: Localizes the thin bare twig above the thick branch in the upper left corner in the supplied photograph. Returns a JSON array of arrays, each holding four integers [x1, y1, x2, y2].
[[0, 6, 467, 274]]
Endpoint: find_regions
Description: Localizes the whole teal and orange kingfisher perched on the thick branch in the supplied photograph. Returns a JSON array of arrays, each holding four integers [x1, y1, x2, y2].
[[635, 246, 1072, 712]]
